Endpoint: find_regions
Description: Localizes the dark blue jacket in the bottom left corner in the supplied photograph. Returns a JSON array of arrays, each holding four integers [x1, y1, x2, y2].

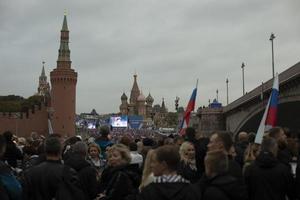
[[0, 161, 22, 200]]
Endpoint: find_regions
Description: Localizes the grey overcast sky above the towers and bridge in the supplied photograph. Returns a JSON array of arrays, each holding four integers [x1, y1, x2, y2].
[[0, 0, 300, 113]]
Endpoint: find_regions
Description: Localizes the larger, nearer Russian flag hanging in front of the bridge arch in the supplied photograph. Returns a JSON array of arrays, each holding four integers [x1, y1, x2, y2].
[[255, 74, 279, 144]]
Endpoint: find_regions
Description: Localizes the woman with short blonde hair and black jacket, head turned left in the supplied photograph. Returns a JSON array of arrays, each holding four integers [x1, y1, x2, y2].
[[100, 144, 140, 200]]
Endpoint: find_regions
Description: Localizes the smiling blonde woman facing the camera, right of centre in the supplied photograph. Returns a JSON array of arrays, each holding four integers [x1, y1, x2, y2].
[[179, 142, 201, 183]]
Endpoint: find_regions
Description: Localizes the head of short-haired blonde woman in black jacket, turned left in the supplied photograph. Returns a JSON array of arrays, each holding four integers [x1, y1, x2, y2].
[[107, 144, 131, 167]]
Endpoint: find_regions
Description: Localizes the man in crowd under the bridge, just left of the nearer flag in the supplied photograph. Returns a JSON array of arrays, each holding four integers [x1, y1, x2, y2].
[[234, 132, 249, 167]]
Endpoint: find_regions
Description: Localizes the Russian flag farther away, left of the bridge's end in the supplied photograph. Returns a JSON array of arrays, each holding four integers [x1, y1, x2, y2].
[[179, 80, 198, 135]]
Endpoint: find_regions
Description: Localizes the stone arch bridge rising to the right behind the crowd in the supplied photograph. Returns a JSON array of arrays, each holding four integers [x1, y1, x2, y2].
[[198, 62, 300, 134]]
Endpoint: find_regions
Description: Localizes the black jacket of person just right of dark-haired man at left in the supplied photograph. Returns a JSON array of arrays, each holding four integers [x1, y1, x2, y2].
[[65, 154, 99, 199]]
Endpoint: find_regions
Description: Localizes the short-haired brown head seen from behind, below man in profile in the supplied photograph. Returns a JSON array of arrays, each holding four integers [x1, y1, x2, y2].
[[204, 150, 228, 177]]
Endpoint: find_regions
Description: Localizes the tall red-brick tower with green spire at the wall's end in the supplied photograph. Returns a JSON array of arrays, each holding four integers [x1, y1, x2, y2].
[[50, 14, 77, 136]]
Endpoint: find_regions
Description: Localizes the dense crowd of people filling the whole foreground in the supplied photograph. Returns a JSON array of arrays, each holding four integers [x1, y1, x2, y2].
[[0, 127, 300, 200]]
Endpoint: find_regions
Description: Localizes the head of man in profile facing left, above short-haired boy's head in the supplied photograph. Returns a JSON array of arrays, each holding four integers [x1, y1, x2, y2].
[[207, 132, 233, 153]]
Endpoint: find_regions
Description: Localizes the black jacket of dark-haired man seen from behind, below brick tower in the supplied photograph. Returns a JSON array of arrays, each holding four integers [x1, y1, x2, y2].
[[23, 160, 85, 200]]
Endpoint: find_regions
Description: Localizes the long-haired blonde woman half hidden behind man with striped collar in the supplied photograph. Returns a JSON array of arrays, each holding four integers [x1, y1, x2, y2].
[[139, 149, 154, 191]]
